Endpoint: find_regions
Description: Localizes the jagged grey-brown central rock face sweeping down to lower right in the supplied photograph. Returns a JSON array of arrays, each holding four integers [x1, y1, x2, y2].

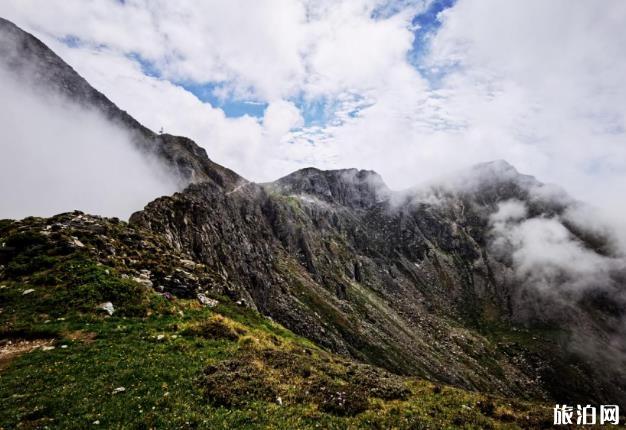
[[131, 162, 624, 406]]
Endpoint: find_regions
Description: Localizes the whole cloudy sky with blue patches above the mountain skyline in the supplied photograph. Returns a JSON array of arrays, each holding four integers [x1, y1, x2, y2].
[[0, 0, 626, 217]]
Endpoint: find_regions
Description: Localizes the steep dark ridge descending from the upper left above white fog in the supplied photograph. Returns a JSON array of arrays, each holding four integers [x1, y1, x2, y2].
[[0, 18, 242, 187]]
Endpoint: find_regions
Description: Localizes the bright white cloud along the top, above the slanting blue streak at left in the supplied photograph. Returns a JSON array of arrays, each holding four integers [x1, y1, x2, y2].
[[0, 0, 418, 100]]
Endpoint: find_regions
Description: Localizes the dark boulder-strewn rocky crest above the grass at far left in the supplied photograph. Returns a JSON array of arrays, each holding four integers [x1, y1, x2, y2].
[[0, 211, 224, 305]]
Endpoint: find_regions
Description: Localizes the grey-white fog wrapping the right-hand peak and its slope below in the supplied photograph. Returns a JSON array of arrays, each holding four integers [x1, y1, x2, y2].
[[396, 161, 626, 377]]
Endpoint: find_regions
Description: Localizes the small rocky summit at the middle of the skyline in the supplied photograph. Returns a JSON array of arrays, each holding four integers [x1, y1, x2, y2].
[[267, 167, 391, 208]]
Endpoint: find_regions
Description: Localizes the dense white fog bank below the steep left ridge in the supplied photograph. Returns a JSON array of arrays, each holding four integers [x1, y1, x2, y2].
[[0, 66, 178, 219]]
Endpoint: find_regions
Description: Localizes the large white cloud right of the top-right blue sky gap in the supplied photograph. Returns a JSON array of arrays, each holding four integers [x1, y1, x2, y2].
[[422, 0, 626, 204]]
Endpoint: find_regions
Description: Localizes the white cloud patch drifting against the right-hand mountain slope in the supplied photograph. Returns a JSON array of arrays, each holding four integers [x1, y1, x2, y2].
[[489, 200, 626, 370]]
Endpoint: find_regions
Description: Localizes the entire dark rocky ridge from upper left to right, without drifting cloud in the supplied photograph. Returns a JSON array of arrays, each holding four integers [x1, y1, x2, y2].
[[0, 19, 626, 410]]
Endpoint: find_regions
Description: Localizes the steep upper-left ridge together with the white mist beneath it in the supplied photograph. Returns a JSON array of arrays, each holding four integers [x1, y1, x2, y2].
[[0, 18, 243, 218]]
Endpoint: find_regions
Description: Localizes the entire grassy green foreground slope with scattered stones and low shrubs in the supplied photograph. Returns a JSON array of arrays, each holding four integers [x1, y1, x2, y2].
[[0, 217, 550, 429]]
